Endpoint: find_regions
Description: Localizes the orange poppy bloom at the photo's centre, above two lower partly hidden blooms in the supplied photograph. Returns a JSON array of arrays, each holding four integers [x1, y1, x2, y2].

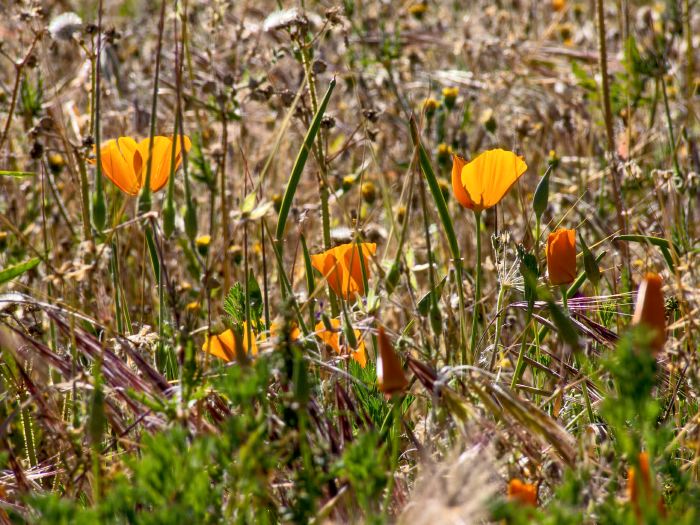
[[311, 242, 377, 299]]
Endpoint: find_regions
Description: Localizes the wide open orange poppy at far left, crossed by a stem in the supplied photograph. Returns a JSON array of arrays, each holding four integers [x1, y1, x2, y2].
[[90, 136, 192, 195]]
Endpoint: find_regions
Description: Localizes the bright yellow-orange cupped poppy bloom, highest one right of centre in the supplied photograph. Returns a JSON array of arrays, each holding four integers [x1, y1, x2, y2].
[[452, 149, 527, 212]]
